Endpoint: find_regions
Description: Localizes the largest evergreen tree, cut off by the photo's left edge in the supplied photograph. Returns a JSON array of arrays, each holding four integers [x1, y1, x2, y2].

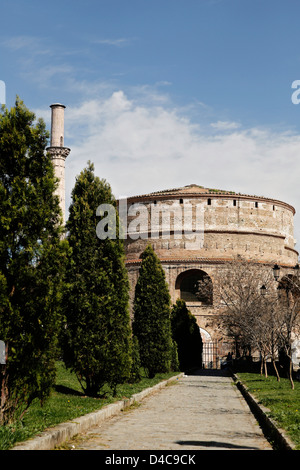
[[0, 98, 67, 424]]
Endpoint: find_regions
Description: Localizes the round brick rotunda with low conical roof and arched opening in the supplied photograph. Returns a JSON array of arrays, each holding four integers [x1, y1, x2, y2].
[[119, 184, 298, 368]]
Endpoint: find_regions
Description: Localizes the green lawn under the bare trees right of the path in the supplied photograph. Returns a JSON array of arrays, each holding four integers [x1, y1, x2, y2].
[[237, 372, 300, 450]]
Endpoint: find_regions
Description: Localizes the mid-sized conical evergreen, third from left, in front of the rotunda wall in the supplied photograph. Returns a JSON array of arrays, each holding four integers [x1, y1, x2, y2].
[[133, 245, 173, 377]]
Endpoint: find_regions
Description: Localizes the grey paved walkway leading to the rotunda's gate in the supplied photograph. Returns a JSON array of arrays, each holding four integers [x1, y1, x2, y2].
[[67, 371, 272, 450]]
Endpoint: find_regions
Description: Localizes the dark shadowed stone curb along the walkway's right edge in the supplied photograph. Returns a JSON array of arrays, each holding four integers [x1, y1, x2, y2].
[[232, 373, 296, 450]]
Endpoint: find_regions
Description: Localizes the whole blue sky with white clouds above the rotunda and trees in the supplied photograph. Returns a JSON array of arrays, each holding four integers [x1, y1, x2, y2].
[[0, 0, 300, 248]]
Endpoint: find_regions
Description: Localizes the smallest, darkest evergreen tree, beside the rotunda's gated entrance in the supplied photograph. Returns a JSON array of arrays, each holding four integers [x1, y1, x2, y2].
[[171, 299, 202, 371]]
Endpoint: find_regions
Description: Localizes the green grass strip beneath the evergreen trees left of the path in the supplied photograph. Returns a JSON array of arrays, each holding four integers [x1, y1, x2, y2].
[[0, 363, 179, 450]]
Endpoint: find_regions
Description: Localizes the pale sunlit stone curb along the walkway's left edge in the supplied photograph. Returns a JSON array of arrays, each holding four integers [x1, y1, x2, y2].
[[10, 373, 184, 450]]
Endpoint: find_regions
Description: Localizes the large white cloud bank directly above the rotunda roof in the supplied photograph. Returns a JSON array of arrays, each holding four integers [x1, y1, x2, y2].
[[42, 91, 300, 248]]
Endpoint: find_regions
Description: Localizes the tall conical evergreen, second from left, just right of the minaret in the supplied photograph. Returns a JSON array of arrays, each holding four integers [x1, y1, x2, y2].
[[64, 162, 132, 396]]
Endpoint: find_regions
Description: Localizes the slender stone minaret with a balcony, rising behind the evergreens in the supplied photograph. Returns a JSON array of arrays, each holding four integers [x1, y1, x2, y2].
[[47, 103, 70, 225]]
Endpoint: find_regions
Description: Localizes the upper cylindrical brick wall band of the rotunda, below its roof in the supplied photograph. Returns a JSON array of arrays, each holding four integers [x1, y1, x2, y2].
[[126, 193, 298, 265]]
